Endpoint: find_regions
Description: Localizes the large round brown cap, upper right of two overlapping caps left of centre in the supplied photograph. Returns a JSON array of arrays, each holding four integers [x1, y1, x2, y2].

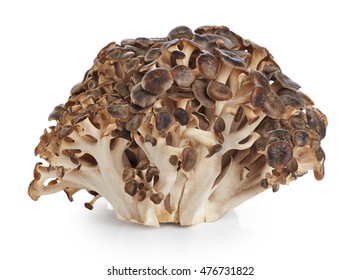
[[141, 68, 173, 95]]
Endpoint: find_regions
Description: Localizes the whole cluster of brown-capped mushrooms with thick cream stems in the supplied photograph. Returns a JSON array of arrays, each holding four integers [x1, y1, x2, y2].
[[28, 26, 327, 226]]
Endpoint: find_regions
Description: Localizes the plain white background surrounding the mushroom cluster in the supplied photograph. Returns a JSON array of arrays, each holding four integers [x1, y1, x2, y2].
[[0, 0, 360, 280]]
